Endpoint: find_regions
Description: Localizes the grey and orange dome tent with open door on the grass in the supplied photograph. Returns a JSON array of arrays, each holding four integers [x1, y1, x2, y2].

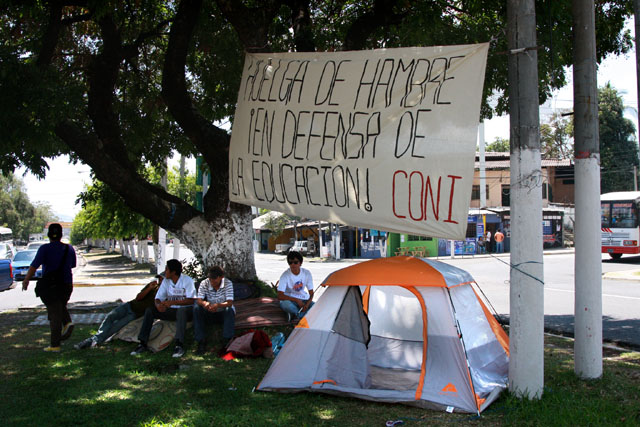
[[257, 256, 509, 413]]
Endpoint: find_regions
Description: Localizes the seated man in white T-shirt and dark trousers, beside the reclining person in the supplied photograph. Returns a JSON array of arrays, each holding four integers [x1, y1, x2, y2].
[[131, 259, 196, 357]]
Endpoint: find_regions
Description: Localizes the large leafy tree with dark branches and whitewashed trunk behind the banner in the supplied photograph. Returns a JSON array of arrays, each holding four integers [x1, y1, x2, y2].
[[0, 0, 632, 277]]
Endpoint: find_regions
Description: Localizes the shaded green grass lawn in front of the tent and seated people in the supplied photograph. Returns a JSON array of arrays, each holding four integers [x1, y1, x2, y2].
[[0, 310, 640, 426]]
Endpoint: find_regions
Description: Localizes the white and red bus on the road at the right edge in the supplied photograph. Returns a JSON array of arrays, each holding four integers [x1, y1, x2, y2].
[[600, 191, 640, 259]]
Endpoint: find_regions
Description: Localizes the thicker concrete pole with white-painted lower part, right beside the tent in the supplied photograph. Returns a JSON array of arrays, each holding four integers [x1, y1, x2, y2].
[[507, 0, 544, 399]]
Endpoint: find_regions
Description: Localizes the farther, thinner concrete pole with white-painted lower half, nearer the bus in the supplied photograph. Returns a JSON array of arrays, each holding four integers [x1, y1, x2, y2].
[[572, 0, 602, 378]]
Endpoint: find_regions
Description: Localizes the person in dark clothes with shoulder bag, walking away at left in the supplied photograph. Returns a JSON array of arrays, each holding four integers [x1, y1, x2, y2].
[[22, 223, 76, 353]]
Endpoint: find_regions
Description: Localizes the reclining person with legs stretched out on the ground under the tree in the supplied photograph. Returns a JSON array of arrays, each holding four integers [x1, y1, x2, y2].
[[73, 274, 164, 350]]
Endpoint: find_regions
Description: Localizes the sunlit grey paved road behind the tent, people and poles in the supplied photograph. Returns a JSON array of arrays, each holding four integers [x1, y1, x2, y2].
[[0, 249, 640, 349]]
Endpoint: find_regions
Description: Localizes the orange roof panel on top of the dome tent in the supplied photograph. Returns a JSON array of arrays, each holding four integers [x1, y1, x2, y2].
[[322, 256, 447, 287]]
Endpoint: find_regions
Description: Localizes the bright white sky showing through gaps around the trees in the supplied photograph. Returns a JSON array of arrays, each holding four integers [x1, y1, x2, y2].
[[16, 19, 638, 221]]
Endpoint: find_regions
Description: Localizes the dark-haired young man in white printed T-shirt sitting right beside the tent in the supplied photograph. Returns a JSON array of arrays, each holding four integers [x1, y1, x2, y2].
[[278, 251, 313, 321]]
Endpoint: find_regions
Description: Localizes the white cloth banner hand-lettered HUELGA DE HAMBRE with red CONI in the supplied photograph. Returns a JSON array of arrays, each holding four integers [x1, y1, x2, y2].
[[229, 43, 489, 239]]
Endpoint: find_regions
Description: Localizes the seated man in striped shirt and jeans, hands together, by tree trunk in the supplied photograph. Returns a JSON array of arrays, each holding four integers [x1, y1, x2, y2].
[[193, 266, 236, 354]]
